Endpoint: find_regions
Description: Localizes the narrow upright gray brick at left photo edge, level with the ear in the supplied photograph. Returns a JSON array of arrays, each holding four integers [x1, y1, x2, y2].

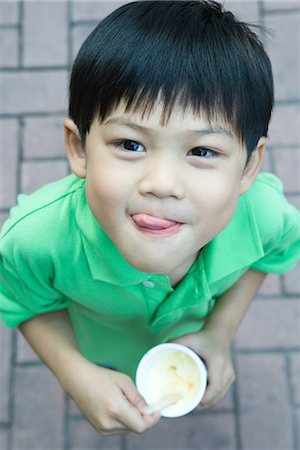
[[0, 119, 19, 208]]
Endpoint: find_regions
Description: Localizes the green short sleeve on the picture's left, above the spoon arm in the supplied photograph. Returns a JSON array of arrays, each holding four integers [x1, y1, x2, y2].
[[0, 233, 68, 328]]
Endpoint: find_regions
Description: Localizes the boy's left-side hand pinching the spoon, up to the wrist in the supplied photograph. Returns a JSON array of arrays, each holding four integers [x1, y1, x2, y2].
[[61, 360, 160, 436]]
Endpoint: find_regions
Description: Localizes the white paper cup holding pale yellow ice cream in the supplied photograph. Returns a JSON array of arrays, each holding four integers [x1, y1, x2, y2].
[[136, 343, 207, 417]]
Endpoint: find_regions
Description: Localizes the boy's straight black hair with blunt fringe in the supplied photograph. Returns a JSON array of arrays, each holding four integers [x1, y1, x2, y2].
[[69, 0, 274, 158]]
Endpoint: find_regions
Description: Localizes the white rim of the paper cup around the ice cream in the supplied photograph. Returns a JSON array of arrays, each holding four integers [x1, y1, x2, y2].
[[136, 342, 207, 417]]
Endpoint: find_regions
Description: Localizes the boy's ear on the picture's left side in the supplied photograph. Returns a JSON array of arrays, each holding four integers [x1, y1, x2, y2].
[[64, 118, 86, 178]]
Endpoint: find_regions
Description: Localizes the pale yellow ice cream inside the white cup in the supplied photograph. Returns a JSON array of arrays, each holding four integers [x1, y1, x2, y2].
[[148, 351, 201, 412]]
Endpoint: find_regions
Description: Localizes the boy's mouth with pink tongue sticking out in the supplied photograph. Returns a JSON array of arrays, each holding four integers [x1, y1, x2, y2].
[[131, 213, 183, 236]]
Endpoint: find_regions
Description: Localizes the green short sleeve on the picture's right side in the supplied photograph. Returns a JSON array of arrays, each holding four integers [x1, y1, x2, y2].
[[252, 174, 300, 274]]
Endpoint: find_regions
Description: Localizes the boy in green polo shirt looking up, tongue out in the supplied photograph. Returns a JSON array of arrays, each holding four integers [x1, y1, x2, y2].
[[0, 1, 300, 434]]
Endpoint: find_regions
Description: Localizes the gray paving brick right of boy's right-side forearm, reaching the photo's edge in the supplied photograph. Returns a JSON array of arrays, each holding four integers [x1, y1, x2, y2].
[[236, 298, 300, 350]]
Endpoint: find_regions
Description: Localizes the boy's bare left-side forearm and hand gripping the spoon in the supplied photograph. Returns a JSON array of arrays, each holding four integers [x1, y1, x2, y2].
[[20, 310, 160, 435]]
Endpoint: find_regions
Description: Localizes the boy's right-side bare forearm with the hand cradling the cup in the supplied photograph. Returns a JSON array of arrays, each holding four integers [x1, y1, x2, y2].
[[174, 270, 266, 407]]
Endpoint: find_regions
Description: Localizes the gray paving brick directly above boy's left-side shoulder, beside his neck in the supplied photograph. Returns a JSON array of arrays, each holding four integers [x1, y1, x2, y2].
[[21, 161, 68, 194]]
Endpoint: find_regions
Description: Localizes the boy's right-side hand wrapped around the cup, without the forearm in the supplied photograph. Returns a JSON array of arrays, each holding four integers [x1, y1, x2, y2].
[[172, 330, 235, 409]]
